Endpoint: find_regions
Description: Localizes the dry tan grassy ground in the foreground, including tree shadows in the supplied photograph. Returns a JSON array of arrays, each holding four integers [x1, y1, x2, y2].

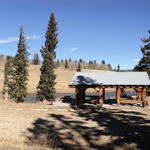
[[0, 100, 150, 150]]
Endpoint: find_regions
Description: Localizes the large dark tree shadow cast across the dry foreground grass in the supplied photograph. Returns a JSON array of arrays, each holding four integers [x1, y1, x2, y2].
[[26, 107, 150, 150]]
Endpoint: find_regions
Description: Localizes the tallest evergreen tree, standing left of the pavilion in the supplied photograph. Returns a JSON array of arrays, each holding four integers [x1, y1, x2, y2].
[[36, 13, 58, 101]]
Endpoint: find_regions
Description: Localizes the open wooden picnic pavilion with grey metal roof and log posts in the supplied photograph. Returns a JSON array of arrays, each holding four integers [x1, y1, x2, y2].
[[69, 72, 150, 106]]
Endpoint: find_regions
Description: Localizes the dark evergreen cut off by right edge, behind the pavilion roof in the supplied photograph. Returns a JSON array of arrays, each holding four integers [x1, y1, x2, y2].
[[134, 30, 150, 76]]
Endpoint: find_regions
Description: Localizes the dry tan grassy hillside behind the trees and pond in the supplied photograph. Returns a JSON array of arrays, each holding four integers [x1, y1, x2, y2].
[[0, 64, 111, 93]]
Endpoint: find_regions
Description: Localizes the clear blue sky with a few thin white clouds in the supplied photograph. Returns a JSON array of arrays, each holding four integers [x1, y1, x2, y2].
[[0, 0, 150, 69]]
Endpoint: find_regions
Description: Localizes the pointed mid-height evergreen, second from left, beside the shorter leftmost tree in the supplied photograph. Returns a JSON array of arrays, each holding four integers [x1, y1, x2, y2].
[[10, 26, 29, 103]]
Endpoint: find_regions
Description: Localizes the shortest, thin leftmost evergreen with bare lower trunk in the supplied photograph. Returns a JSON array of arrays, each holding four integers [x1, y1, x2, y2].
[[2, 56, 13, 101]]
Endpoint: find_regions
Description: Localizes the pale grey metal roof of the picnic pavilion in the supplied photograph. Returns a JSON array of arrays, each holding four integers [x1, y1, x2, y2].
[[71, 72, 150, 85]]
